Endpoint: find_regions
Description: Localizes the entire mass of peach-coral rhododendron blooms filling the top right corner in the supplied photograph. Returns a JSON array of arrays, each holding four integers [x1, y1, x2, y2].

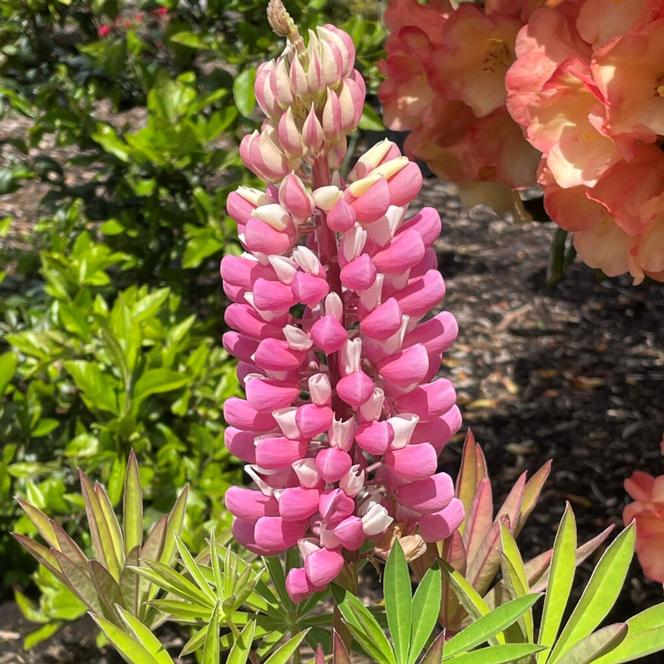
[[379, 0, 664, 283]]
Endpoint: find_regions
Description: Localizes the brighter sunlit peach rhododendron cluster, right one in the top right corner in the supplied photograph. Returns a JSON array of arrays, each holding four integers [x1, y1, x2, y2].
[[506, 0, 664, 283]]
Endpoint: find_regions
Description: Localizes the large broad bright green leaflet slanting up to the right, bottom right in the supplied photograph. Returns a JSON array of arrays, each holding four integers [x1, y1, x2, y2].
[[548, 523, 636, 664]]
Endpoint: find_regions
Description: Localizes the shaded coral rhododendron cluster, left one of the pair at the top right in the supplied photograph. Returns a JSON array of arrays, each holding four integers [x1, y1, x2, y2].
[[379, 0, 539, 196]]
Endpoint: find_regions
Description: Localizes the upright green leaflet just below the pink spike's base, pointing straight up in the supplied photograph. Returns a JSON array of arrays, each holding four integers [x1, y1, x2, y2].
[[383, 540, 412, 664]]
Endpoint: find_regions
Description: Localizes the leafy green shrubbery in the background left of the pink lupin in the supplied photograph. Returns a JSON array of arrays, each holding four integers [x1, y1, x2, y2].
[[0, 0, 384, 632]]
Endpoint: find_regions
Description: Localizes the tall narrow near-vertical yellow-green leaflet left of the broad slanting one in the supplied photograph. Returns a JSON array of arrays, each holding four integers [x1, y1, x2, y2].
[[537, 503, 576, 664]]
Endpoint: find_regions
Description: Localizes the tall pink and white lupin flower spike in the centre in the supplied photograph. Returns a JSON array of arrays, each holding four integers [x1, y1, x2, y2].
[[221, 2, 463, 601]]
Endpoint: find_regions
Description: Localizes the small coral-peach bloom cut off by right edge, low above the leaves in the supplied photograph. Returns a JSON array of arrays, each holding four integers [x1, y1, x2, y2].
[[623, 471, 664, 583]]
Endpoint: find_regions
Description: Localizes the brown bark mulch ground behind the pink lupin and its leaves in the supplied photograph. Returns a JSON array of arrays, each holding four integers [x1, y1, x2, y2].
[[0, 167, 664, 664]]
